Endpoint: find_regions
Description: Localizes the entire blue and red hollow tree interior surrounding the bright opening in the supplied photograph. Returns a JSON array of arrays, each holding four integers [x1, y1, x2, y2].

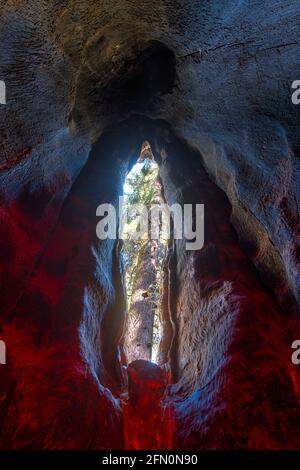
[[0, 0, 300, 449]]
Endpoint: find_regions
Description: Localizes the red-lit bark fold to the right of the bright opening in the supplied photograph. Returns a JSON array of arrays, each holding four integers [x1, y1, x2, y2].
[[151, 126, 300, 450]]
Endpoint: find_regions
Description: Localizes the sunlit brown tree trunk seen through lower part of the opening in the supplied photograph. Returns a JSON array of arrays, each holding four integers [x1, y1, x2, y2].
[[126, 240, 157, 363]]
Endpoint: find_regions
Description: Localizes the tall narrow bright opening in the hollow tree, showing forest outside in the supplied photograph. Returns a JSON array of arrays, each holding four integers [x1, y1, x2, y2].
[[123, 142, 168, 363]]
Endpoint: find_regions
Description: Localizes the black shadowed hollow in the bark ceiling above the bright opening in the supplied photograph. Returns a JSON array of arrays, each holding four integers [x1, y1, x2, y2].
[[69, 41, 177, 136]]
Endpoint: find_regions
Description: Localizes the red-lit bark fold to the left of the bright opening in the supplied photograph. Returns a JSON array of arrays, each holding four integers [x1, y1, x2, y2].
[[0, 121, 141, 449]]
